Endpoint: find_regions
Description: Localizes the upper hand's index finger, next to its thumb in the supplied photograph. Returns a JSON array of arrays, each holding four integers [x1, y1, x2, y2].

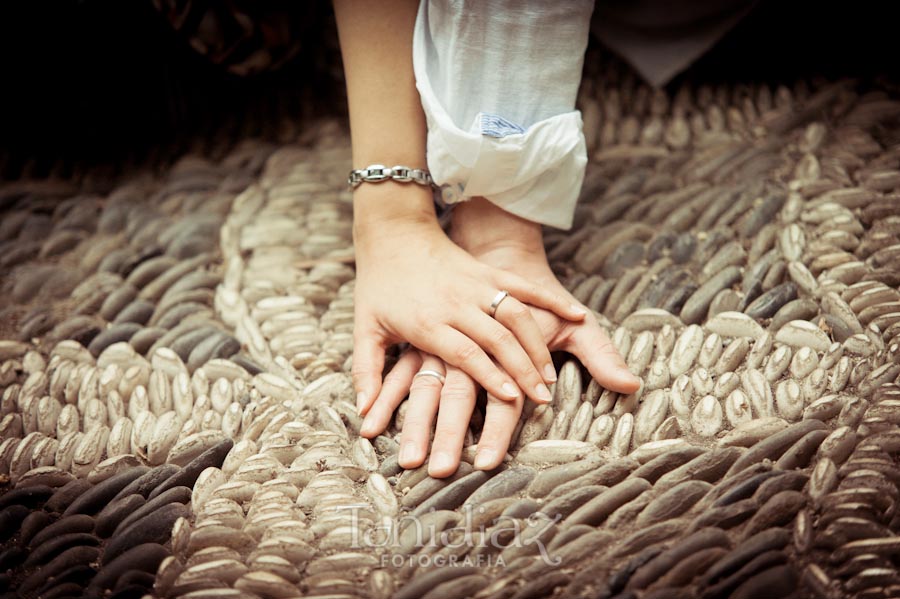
[[428, 326, 521, 400]]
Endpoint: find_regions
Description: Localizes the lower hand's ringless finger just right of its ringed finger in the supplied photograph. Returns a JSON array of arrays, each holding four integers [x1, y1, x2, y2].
[[428, 367, 476, 478]]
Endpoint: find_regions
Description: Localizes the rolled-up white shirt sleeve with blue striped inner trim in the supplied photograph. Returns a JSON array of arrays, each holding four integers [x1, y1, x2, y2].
[[413, 0, 593, 229]]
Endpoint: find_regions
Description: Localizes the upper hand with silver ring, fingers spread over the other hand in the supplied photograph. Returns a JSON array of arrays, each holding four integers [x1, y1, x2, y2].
[[352, 184, 586, 412]]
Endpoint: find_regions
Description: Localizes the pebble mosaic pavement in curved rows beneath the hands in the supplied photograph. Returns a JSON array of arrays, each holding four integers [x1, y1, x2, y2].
[[0, 68, 900, 599]]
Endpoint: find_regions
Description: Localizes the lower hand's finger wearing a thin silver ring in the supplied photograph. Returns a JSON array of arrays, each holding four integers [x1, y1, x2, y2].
[[398, 355, 444, 469]]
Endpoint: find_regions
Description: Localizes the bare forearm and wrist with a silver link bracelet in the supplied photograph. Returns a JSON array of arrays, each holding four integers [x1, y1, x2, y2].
[[334, 0, 435, 233]]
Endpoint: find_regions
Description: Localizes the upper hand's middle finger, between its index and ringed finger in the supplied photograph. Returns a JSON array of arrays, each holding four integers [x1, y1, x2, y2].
[[451, 309, 551, 403]]
